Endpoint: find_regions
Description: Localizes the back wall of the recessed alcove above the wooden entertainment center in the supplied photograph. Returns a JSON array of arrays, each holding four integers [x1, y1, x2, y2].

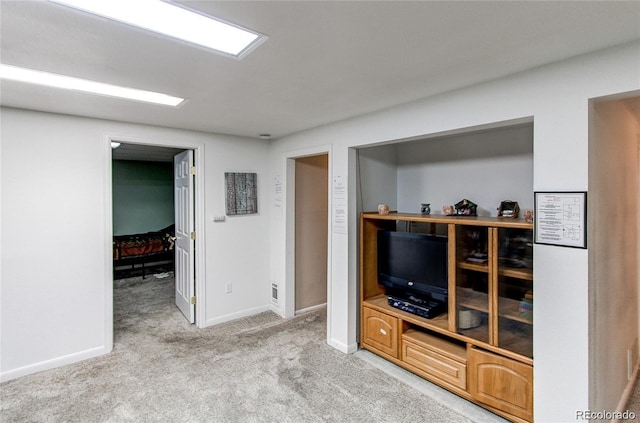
[[397, 125, 533, 216]]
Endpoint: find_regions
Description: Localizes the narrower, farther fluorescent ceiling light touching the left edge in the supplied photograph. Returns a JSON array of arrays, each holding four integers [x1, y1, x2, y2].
[[0, 64, 184, 106]]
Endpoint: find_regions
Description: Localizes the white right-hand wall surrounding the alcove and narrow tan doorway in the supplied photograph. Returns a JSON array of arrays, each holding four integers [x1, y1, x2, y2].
[[270, 43, 640, 422]]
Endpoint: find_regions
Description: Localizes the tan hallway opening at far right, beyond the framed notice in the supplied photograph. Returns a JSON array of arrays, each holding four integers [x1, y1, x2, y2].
[[588, 91, 640, 409]]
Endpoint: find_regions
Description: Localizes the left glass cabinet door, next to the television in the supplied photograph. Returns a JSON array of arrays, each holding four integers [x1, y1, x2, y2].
[[455, 225, 491, 343]]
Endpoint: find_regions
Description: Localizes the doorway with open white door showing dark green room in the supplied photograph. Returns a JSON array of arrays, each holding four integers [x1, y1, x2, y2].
[[111, 141, 204, 334]]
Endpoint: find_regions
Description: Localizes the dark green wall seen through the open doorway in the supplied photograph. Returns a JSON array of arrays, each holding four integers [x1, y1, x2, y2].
[[112, 160, 174, 235]]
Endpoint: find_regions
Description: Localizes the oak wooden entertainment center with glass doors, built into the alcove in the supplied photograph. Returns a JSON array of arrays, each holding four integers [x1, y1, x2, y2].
[[360, 213, 533, 422]]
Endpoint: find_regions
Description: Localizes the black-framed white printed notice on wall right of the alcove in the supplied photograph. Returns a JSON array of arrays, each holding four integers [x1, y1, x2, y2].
[[534, 191, 587, 248]]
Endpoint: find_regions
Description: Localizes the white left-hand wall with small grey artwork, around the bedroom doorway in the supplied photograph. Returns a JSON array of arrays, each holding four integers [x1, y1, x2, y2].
[[0, 108, 270, 380]]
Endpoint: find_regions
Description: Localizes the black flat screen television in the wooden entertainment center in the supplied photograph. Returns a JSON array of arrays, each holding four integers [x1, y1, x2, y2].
[[378, 230, 449, 303]]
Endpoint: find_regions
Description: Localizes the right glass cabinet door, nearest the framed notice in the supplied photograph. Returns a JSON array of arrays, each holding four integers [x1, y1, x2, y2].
[[495, 228, 533, 357]]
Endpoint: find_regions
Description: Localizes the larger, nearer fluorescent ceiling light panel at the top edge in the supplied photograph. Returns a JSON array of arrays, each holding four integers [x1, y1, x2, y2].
[[51, 0, 265, 57]]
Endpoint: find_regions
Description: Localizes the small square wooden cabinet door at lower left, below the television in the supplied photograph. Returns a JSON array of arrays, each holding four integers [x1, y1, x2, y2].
[[362, 307, 400, 358]]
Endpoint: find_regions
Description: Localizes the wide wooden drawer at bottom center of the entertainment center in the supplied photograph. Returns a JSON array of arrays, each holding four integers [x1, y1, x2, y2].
[[402, 337, 467, 389]]
